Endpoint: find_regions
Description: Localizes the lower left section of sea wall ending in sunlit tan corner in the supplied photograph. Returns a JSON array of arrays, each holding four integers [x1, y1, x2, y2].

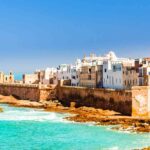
[[0, 84, 55, 101]]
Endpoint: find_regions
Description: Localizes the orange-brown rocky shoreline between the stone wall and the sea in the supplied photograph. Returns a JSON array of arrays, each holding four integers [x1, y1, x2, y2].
[[0, 95, 150, 133]]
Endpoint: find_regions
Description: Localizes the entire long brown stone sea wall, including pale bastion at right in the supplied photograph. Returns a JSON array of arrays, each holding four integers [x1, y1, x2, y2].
[[0, 84, 150, 117]]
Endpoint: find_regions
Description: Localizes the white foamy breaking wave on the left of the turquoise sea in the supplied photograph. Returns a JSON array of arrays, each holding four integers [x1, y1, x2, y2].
[[0, 105, 67, 122]]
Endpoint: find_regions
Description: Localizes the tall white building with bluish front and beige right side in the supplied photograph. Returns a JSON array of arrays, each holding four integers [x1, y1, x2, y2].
[[103, 52, 138, 89]]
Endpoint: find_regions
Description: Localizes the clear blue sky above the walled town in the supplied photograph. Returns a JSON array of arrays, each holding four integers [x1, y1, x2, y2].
[[0, 0, 150, 72]]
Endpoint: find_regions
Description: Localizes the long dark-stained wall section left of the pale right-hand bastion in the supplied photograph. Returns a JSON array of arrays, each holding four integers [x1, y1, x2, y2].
[[57, 86, 132, 115]]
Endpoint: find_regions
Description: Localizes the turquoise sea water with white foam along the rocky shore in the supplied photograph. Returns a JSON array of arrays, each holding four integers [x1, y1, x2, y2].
[[0, 105, 150, 150]]
